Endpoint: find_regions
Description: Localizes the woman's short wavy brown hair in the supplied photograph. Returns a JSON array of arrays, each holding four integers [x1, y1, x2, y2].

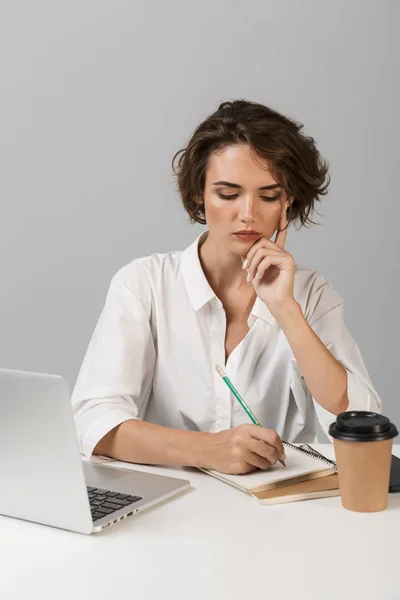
[[172, 100, 330, 227]]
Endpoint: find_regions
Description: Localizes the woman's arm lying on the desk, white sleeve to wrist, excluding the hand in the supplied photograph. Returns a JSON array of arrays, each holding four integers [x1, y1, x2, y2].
[[72, 273, 217, 466]]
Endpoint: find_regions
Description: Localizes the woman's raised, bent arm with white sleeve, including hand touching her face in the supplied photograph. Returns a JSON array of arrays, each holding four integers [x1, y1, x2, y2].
[[239, 209, 381, 429]]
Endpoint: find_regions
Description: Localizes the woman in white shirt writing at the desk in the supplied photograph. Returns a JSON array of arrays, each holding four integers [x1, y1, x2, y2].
[[72, 100, 381, 473]]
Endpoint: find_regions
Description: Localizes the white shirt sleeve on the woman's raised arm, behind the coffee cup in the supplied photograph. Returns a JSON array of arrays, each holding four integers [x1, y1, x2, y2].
[[309, 277, 382, 440]]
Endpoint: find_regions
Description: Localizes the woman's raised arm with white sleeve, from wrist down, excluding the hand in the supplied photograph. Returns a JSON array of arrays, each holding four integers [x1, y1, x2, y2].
[[274, 276, 382, 438]]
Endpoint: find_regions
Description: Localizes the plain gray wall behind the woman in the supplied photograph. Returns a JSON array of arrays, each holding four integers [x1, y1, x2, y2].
[[0, 0, 400, 425]]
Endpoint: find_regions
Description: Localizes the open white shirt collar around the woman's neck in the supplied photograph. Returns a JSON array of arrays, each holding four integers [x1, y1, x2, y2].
[[181, 231, 275, 325]]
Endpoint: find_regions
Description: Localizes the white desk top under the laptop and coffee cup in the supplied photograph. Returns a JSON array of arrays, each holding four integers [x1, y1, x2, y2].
[[0, 445, 400, 600]]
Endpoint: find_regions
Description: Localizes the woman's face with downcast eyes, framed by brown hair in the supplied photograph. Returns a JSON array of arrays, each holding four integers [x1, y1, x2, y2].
[[203, 144, 288, 255]]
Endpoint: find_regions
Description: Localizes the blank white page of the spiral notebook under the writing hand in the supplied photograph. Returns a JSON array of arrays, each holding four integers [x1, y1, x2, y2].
[[203, 440, 331, 492]]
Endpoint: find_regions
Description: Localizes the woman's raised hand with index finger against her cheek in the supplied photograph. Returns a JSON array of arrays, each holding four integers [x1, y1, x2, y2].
[[243, 207, 295, 312]]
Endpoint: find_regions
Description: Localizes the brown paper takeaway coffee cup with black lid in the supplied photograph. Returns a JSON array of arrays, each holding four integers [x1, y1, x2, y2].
[[329, 410, 398, 512]]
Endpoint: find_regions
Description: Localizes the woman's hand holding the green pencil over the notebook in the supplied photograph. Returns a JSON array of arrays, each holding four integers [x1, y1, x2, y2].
[[202, 424, 285, 475]]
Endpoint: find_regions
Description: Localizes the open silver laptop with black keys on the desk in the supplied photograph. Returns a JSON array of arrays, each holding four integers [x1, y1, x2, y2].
[[0, 369, 190, 534]]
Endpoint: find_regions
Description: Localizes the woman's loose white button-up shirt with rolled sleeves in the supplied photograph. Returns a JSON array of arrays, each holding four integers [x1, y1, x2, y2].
[[72, 233, 381, 456]]
